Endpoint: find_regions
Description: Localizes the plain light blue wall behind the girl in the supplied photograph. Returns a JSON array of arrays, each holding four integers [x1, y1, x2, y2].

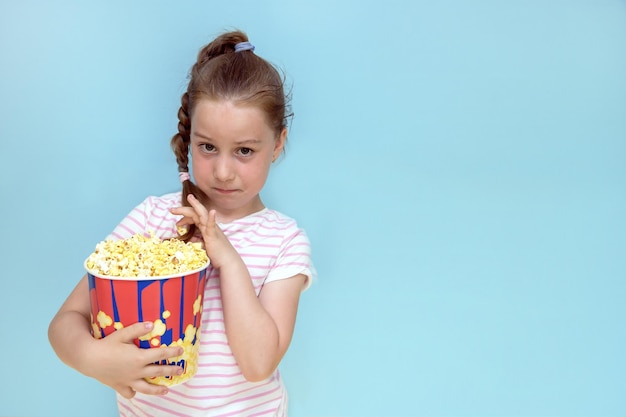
[[0, 0, 626, 417]]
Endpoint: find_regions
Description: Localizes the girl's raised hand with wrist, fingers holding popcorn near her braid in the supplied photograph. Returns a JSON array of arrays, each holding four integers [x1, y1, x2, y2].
[[170, 194, 241, 269]]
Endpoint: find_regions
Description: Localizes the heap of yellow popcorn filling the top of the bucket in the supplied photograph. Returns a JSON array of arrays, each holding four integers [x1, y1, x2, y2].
[[86, 234, 209, 277]]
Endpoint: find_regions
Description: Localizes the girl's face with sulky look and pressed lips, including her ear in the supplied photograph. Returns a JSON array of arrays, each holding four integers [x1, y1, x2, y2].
[[190, 99, 287, 222]]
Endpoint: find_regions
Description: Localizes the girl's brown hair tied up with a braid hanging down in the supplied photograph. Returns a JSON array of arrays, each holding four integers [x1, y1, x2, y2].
[[170, 31, 292, 241]]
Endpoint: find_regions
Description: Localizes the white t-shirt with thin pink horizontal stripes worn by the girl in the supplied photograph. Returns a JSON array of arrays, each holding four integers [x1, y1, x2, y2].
[[110, 192, 314, 417]]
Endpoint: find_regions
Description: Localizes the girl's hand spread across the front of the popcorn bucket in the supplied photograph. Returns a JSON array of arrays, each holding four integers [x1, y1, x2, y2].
[[83, 322, 183, 398]]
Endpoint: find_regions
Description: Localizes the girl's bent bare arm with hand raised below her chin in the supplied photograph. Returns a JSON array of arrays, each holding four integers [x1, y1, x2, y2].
[[171, 195, 306, 381]]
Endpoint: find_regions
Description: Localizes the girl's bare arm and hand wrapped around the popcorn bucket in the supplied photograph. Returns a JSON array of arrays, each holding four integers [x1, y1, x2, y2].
[[48, 276, 182, 398]]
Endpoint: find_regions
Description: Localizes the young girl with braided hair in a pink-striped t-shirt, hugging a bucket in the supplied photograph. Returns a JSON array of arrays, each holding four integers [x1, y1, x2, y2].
[[49, 32, 313, 416]]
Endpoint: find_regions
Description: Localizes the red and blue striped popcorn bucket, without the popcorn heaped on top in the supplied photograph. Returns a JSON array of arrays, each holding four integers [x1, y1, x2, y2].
[[85, 261, 209, 386]]
